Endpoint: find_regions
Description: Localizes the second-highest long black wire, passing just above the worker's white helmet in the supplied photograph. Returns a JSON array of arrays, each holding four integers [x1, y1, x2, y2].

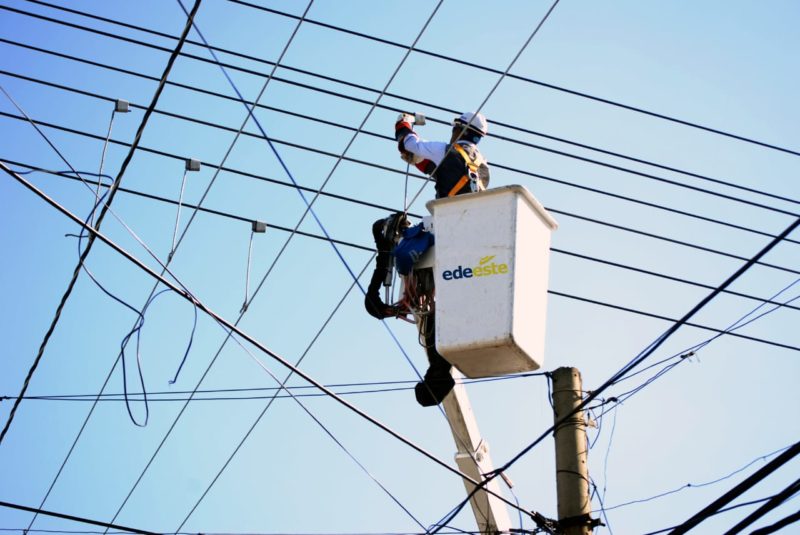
[[15, 0, 800, 208]]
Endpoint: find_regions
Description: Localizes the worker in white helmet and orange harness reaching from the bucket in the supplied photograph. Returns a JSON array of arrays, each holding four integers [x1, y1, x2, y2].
[[395, 112, 489, 199]]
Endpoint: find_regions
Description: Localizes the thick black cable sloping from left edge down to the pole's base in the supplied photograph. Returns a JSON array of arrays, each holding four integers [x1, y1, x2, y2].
[[0, 162, 536, 528]]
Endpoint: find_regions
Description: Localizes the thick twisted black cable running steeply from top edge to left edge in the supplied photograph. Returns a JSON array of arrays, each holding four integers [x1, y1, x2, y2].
[[0, 0, 202, 444]]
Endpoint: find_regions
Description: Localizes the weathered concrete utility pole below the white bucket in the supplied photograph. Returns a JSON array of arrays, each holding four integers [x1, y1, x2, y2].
[[553, 368, 594, 535]]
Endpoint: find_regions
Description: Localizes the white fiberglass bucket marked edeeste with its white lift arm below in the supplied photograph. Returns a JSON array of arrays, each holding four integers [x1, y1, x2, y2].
[[414, 186, 558, 533]]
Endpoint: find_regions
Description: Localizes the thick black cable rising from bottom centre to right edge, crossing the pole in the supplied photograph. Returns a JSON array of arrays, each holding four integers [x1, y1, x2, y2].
[[432, 213, 800, 524]]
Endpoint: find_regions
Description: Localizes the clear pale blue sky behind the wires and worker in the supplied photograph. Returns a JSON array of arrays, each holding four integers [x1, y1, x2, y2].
[[0, 0, 800, 535]]
